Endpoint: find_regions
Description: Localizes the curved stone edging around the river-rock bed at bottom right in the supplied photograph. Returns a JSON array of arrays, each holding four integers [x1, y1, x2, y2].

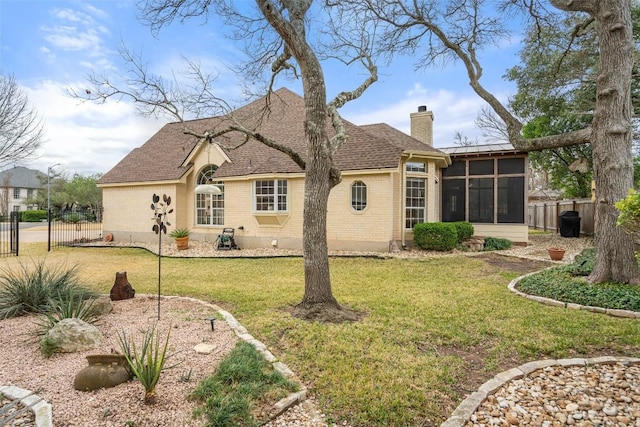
[[440, 356, 640, 427]]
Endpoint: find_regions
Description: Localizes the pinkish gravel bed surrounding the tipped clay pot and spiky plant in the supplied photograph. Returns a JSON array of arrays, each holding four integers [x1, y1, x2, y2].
[[0, 297, 237, 427]]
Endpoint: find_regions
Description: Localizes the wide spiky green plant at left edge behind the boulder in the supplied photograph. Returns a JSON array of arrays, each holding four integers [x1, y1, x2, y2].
[[0, 259, 96, 319]]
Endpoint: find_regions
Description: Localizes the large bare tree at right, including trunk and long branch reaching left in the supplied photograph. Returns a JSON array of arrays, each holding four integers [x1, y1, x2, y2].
[[358, 0, 640, 283]]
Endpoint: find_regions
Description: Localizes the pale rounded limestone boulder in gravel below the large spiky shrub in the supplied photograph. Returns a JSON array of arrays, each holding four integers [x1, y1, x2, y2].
[[47, 318, 102, 353]]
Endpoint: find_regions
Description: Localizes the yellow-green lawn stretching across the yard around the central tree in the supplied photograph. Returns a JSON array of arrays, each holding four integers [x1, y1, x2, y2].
[[7, 244, 640, 426]]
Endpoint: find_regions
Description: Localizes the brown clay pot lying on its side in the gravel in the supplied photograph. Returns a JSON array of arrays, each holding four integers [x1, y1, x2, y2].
[[73, 354, 131, 391]]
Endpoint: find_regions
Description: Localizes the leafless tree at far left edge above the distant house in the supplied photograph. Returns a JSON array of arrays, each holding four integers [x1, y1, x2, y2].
[[0, 74, 44, 169]]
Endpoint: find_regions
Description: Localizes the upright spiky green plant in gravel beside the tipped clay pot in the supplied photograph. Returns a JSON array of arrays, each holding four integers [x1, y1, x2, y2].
[[117, 325, 171, 404]]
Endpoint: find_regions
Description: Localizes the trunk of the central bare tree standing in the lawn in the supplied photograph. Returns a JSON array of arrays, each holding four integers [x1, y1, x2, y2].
[[257, 0, 357, 322]]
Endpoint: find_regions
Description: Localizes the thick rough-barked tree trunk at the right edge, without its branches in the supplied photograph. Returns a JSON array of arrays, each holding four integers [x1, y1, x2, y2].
[[589, 0, 639, 283]]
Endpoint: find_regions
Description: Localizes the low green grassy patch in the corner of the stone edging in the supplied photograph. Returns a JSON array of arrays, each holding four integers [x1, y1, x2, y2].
[[190, 342, 297, 427]]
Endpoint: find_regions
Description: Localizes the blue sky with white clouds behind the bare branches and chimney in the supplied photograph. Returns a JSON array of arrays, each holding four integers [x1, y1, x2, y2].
[[0, 0, 517, 176]]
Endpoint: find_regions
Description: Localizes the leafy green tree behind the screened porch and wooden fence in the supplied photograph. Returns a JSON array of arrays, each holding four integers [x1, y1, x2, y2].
[[506, 3, 640, 198]]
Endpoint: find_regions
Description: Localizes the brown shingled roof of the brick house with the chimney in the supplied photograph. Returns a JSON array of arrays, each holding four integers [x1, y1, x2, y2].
[[98, 88, 446, 184]]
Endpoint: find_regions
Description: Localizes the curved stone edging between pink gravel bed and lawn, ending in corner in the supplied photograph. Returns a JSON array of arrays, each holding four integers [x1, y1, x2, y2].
[[158, 294, 307, 419]]
